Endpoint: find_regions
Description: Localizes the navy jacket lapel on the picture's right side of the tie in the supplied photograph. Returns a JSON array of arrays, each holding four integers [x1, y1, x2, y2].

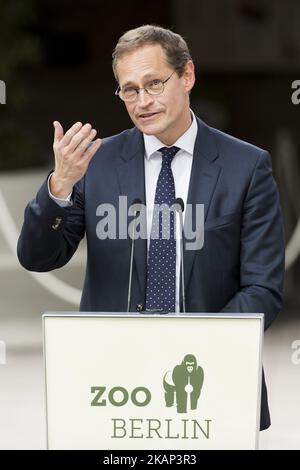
[[184, 119, 221, 289]]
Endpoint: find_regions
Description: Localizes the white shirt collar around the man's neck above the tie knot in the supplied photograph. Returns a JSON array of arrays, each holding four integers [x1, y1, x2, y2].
[[143, 110, 198, 160]]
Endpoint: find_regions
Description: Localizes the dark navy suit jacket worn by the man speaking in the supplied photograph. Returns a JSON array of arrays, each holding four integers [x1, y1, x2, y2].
[[18, 119, 284, 429]]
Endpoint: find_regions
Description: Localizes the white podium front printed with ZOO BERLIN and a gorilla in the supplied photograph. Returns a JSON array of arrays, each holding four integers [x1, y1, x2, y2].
[[43, 313, 264, 450]]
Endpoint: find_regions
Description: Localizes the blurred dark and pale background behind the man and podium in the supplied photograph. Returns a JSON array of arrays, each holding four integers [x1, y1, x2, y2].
[[0, 0, 300, 448]]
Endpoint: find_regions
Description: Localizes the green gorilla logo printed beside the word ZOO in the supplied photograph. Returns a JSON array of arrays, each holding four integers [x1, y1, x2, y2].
[[163, 354, 204, 413]]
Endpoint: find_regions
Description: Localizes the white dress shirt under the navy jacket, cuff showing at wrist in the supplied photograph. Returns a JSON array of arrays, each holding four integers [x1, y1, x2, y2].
[[48, 111, 198, 312]]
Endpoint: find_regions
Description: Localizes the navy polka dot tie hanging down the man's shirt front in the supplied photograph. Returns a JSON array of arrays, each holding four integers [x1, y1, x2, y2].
[[146, 147, 179, 312]]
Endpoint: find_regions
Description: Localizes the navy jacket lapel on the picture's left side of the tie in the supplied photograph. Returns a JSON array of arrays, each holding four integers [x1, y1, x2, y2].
[[116, 128, 147, 300]]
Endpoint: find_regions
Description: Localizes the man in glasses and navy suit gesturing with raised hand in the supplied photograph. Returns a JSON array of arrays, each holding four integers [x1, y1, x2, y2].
[[18, 26, 284, 429]]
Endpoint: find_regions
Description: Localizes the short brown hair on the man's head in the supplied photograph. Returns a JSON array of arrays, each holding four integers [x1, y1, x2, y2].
[[112, 25, 191, 80]]
